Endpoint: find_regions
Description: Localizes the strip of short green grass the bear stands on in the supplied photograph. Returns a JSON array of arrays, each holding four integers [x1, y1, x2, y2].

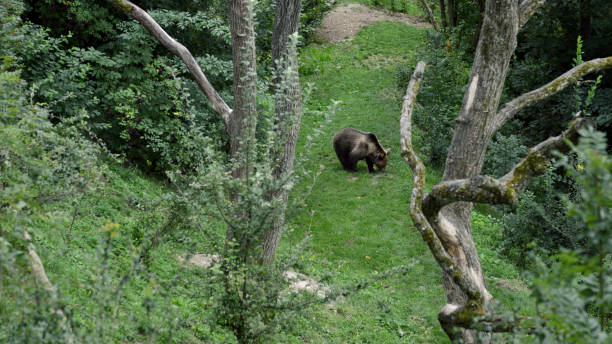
[[283, 22, 527, 343]]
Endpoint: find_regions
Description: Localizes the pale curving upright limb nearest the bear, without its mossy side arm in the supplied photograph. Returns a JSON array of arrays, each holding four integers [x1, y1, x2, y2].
[[400, 61, 483, 303]]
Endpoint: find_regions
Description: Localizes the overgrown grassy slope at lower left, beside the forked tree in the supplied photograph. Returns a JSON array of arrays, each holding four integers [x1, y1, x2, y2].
[[25, 162, 231, 343]]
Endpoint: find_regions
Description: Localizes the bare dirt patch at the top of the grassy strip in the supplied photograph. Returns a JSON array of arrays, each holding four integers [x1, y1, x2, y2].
[[317, 3, 431, 42]]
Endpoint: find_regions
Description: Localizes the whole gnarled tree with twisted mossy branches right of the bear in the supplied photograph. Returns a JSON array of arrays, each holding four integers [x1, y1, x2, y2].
[[400, 0, 612, 343]]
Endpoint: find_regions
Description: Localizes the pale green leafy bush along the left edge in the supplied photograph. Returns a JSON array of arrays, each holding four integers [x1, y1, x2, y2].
[[0, 1, 105, 343]]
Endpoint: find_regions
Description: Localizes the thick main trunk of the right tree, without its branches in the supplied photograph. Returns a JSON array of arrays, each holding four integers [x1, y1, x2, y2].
[[440, 0, 519, 343]]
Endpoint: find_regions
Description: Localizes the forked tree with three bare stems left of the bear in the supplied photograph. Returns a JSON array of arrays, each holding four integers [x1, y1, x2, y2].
[[106, 0, 302, 263]]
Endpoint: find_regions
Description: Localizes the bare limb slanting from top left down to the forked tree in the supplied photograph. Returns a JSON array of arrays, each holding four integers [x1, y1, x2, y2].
[[106, 0, 232, 129]]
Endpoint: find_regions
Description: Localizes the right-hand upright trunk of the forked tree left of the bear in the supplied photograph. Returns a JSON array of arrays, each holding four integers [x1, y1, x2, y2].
[[263, 0, 302, 264]]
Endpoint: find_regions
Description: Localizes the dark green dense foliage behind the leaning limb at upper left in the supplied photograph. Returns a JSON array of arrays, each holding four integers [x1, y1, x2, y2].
[[19, 0, 329, 173]]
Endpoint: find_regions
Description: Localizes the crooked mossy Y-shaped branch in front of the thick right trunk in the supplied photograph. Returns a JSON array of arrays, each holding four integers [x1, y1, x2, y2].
[[400, 62, 589, 339]]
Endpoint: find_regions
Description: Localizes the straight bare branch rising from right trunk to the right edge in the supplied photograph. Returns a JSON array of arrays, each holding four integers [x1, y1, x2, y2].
[[495, 56, 612, 131]]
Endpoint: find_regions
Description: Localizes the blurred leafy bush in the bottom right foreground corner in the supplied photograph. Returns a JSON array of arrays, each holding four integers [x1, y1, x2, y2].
[[512, 129, 612, 343]]
